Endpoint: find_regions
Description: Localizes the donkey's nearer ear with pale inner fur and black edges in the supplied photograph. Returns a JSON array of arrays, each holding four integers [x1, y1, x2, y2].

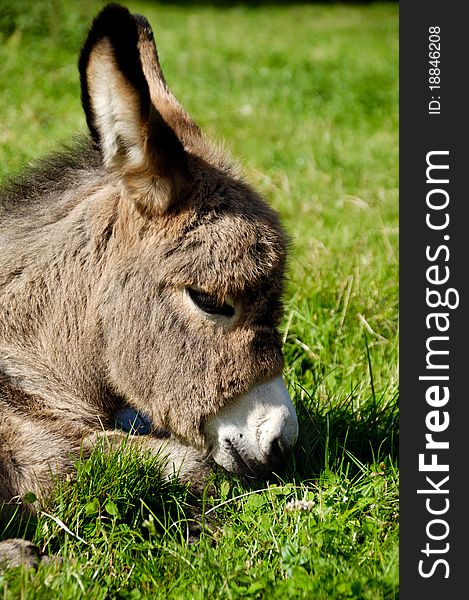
[[79, 4, 187, 213]]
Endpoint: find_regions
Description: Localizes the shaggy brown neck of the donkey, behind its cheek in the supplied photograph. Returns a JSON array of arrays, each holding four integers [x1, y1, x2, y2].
[[0, 166, 117, 411]]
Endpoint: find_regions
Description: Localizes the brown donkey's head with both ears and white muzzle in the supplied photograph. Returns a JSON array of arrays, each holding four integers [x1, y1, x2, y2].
[[79, 5, 298, 474]]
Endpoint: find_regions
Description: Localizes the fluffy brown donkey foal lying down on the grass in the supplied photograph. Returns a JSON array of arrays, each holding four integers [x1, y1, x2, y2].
[[0, 4, 298, 568]]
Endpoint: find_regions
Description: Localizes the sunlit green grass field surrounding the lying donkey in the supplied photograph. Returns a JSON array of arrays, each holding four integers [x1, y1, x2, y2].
[[0, 0, 398, 600]]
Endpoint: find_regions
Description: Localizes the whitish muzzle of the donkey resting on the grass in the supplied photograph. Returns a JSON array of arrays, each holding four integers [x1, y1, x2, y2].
[[205, 377, 298, 476]]
